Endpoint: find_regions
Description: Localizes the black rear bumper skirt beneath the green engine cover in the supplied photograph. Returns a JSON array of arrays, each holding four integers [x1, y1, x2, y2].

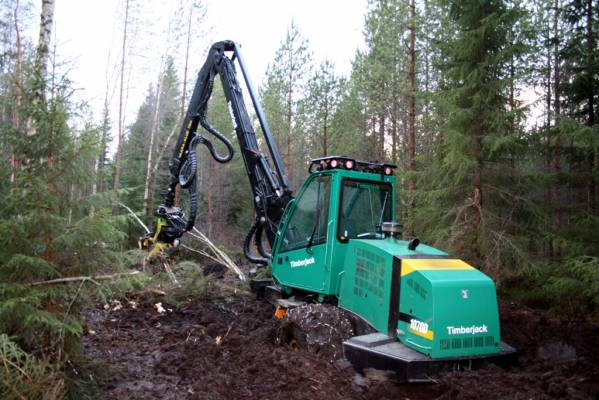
[[343, 332, 517, 383]]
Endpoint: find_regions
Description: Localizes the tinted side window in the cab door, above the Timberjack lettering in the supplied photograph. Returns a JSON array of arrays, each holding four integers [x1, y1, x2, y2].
[[280, 175, 331, 252]]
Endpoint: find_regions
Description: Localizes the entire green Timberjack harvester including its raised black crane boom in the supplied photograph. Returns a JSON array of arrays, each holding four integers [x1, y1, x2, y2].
[[143, 41, 515, 382]]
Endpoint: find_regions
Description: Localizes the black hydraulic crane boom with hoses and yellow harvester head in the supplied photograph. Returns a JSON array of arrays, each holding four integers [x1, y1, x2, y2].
[[144, 40, 293, 265]]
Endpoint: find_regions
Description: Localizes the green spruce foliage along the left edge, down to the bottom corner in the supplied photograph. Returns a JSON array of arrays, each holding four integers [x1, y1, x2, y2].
[[0, 20, 137, 399]]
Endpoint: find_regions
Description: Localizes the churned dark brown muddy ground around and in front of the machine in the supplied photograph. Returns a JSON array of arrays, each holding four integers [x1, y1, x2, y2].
[[84, 290, 599, 400]]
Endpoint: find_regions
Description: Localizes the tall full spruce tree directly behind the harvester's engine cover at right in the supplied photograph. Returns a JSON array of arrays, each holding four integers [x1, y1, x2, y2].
[[420, 0, 522, 267]]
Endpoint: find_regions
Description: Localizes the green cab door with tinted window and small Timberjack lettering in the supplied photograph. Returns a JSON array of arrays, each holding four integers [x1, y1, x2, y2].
[[272, 175, 333, 293]]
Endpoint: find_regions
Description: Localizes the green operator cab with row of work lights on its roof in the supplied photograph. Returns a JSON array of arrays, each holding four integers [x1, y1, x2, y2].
[[272, 156, 395, 295]]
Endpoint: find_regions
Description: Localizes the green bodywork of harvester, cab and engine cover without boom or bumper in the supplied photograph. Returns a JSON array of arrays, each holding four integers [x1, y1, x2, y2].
[[272, 168, 501, 359]]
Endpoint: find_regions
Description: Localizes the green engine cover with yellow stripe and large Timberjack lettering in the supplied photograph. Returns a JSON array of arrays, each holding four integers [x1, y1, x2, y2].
[[339, 238, 501, 358]]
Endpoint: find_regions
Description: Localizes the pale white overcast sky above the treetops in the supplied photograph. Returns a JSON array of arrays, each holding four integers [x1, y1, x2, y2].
[[43, 0, 367, 131]]
